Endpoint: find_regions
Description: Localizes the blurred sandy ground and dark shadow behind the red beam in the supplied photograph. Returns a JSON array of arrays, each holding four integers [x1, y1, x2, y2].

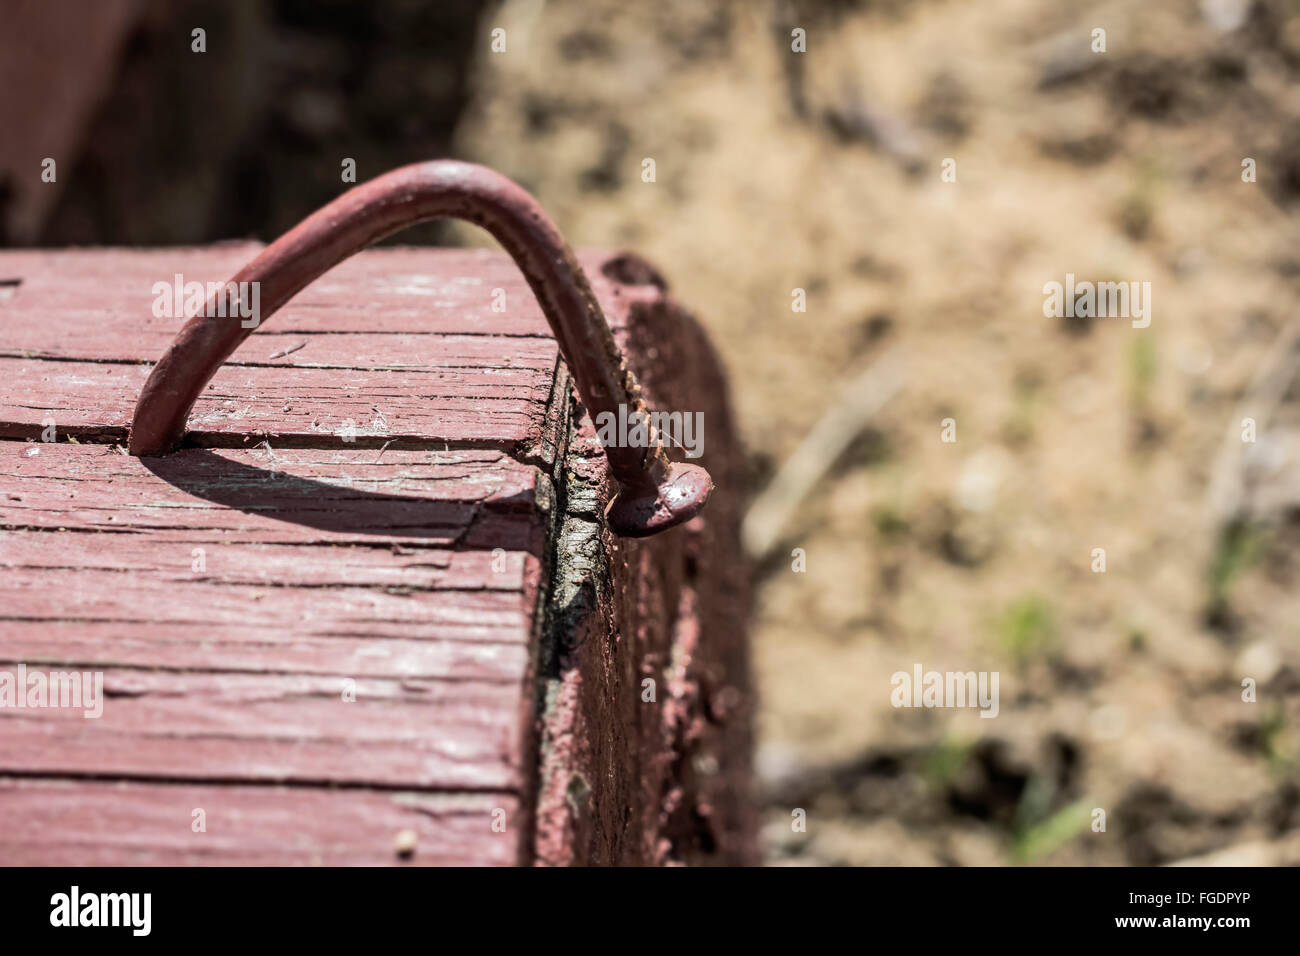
[[15, 0, 1300, 865]]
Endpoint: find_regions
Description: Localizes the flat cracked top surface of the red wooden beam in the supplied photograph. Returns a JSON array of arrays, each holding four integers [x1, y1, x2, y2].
[[0, 243, 595, 864]]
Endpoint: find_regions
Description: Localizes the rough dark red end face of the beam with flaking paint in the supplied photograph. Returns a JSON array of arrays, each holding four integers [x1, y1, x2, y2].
[[537, 269, 757, 865]]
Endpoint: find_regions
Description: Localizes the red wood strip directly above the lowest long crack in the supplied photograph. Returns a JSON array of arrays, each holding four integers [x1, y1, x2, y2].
[[0, 669, 523, 792]]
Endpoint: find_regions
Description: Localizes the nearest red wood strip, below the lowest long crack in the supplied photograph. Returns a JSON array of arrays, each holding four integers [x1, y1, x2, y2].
[[0, 778, 521, 866]]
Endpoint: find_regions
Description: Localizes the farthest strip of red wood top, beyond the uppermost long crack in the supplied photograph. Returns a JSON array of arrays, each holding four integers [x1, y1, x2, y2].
[[0, 242, 641, 340]]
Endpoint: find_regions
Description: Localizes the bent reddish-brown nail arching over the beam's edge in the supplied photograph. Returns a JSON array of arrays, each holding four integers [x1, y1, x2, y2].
[[127, 160, 712, 537]]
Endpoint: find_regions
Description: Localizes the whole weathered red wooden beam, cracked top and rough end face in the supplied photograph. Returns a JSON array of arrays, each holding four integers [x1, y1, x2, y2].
[[0, 243, 753, 865]]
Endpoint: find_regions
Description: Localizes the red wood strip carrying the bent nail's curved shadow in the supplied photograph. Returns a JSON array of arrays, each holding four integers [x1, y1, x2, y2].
[[0, 441, 550, 550]]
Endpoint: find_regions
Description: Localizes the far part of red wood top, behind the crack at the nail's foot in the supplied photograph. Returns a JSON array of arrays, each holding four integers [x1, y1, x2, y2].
[[0, 251, 632, 449]]
